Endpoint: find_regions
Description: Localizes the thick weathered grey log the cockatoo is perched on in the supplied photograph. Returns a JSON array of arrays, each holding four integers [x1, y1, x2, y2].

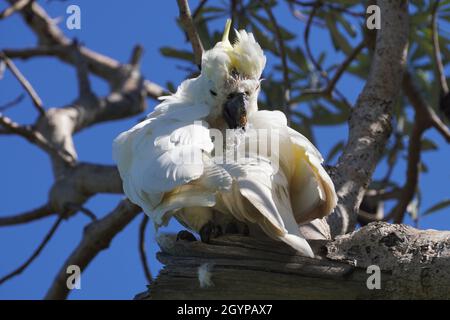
[[136, 222, 450, 299]]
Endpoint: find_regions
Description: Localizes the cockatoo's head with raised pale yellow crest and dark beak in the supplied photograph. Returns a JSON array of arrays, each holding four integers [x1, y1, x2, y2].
[[201, 20, 266, 129]]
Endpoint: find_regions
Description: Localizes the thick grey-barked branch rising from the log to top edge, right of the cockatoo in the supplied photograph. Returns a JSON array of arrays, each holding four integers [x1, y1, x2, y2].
[[328, 0, 409, 235]]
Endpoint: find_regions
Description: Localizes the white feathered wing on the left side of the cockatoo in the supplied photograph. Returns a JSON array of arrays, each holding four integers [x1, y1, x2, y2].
[[113, 104, 231, 224]]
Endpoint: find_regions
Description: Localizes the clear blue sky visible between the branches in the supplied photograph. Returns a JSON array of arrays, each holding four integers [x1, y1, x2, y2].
[[0, 0, 450, 299]]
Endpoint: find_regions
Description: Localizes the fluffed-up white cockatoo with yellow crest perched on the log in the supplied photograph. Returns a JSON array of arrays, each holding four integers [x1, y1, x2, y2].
[[113, 20, 337, 257]]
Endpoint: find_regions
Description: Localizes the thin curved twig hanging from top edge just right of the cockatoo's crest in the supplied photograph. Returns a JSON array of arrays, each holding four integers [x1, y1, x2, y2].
[[259, 0, 291, 123]]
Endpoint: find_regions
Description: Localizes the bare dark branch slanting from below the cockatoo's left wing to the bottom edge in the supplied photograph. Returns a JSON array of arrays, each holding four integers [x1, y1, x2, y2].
[[45, 200, 141, 300]]
